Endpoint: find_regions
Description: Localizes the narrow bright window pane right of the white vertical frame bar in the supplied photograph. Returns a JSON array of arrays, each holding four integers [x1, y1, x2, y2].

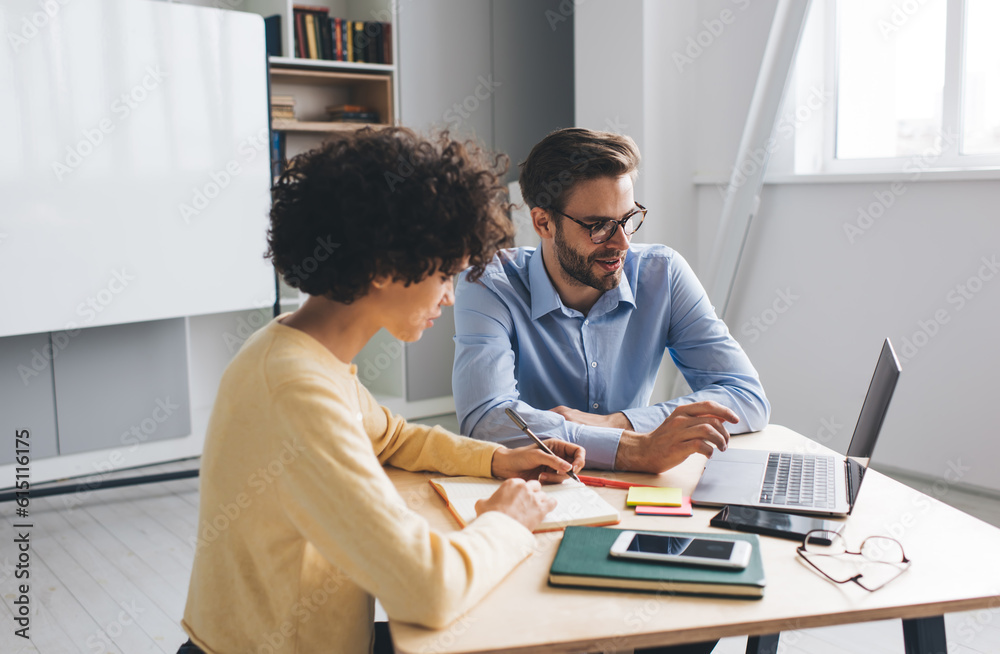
[[962, 0, 1000, 154]]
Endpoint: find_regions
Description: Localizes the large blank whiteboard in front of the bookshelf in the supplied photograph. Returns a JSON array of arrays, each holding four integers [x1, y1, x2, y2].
[[0, 0, 275, 336]]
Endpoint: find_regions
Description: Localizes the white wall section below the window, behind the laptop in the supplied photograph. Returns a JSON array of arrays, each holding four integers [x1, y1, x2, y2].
[[716, 181, 1000, 489]]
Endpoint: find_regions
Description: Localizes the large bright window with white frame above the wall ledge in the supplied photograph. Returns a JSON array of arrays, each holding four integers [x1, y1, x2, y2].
[[784, 0, 1000, 173]]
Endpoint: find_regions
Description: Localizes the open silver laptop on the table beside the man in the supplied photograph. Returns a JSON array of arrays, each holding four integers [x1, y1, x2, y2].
[[691, 339, 902, 516]]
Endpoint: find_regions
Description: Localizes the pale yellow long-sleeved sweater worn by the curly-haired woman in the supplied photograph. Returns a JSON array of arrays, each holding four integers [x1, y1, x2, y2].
[[182, 320, 534, 654]]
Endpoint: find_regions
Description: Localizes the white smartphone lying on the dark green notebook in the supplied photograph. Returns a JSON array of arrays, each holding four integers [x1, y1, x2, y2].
[[611, 531, 752, 570]]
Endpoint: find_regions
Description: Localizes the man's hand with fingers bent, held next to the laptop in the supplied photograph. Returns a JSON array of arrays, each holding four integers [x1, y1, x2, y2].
[[615, 401, 740, 473]]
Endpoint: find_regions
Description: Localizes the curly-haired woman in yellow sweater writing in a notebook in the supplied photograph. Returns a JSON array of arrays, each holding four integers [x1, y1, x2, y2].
[[181, 128, 584, 653]]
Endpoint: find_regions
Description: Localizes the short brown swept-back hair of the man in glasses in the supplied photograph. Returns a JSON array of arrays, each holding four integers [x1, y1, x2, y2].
[[518, 127, 639, 210]]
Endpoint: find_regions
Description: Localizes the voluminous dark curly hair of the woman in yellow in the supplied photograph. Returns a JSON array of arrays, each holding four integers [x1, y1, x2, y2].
[[264, 127, 513, 304]]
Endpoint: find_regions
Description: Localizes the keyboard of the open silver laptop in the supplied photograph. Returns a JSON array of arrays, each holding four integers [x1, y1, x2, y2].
[[760, 452, 836, 509]]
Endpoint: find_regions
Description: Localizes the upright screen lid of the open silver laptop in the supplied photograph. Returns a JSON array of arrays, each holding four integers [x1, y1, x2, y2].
[[847, 338, 902, 507]]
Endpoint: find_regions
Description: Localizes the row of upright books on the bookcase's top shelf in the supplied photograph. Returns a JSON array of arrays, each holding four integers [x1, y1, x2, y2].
[[292, 5, 392, 64]]
